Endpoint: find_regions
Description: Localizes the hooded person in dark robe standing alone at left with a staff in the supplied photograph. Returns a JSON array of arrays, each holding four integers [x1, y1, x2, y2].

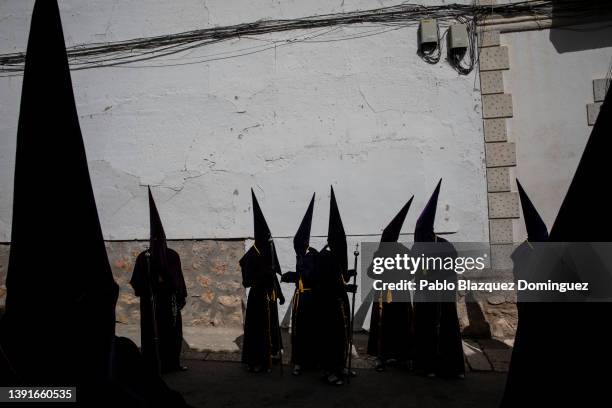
[[130, 188, 187, 373]]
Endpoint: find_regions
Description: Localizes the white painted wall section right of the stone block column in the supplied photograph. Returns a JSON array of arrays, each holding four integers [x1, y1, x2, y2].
[[501, 24, 612, 241]]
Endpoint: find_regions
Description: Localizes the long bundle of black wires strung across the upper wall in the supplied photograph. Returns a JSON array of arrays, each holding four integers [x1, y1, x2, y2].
[[0, 0, 610, 75]]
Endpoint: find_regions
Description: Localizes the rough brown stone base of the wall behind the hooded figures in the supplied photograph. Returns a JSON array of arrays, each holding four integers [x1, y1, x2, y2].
[[0, 240, 516, 338]]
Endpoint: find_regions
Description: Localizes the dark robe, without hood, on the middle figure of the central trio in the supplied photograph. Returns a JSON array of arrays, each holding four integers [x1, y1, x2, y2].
[[283, 248, 320, 368]]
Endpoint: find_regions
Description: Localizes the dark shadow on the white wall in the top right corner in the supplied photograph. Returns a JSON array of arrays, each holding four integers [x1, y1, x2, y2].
[[549, 0, 612, 54]]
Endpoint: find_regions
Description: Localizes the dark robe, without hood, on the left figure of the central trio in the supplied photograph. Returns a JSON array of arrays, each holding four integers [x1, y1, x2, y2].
[[240, 246, 282, 369]]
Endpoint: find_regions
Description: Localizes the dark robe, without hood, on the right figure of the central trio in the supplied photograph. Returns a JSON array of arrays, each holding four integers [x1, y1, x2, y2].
[[314, 247, 351, 376]]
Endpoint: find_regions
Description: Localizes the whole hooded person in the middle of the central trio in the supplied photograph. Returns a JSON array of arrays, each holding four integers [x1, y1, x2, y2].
[[282, 194, 320, 375]]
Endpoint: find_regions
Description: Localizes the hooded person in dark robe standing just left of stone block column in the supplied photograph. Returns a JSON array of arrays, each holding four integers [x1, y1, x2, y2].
[[412, 180, 465, 377]]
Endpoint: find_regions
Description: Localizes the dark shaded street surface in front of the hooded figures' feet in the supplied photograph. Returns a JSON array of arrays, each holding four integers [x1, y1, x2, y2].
[[165, 360, 506, 408]]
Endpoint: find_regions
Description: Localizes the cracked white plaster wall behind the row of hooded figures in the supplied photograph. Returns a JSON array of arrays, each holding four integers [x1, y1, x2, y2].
[[0, 0, 488, 326]]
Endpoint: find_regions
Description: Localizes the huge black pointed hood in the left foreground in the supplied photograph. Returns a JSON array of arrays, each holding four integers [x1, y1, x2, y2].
[[2, 0, 118, 388]]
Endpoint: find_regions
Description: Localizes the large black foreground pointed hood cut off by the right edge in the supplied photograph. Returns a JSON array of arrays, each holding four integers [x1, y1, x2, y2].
[[549, 87, 612, 242]]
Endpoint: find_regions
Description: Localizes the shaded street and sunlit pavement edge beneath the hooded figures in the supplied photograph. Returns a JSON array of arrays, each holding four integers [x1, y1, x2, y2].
[[117, 325, 512, 408]]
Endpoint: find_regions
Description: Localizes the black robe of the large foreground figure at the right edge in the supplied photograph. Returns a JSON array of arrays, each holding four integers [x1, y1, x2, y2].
[[501, 243, 612, 408]]
